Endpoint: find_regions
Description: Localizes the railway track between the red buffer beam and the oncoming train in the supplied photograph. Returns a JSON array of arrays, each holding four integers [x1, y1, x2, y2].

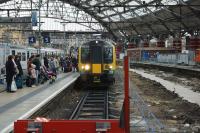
[[70, 89, 108, 120]]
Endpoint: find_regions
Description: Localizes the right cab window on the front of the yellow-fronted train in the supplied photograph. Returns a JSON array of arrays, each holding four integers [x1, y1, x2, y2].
[[104, 47, 113, 63]]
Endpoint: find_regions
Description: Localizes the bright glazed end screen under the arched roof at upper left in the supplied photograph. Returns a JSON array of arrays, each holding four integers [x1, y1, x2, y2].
[[0, 0, 105, 31]]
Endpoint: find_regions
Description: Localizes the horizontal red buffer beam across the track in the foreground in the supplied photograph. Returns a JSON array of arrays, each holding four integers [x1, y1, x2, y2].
[[14, 120, 126, 133]]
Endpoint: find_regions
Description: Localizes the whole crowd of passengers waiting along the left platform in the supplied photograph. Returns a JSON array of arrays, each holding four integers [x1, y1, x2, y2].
[[6, 54, 78, 92]]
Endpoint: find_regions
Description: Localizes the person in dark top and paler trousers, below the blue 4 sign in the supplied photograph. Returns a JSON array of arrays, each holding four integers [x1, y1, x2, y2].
[[32, 54, 41, 85]]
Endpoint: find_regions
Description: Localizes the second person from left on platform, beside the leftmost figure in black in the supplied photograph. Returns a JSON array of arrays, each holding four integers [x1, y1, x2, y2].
[[15, 55, 23, 89]]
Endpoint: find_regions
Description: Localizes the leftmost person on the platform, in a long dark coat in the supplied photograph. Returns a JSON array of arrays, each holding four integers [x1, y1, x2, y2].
[[6, 55, 16, 92]]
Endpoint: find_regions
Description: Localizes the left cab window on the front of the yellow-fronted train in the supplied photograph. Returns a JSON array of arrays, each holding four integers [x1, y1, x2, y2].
[[81, 47, 90, 63]]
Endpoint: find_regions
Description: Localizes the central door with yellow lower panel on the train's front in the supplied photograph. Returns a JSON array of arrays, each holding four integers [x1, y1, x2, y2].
[[90, 45, 103, 74]]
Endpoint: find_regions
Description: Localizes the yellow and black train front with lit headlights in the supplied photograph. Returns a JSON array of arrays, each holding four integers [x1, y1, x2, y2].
[[78, 40, 116, 84]]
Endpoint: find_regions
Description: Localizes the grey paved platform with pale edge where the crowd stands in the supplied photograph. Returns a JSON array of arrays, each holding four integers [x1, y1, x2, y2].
[[0, 72, 79, 133]]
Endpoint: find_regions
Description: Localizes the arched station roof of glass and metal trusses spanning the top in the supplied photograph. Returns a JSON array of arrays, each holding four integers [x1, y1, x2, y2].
[[0, 0, 200, 37]]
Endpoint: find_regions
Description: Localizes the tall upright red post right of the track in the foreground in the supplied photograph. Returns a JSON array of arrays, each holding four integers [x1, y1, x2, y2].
[[124, 56, 130, 133]]
